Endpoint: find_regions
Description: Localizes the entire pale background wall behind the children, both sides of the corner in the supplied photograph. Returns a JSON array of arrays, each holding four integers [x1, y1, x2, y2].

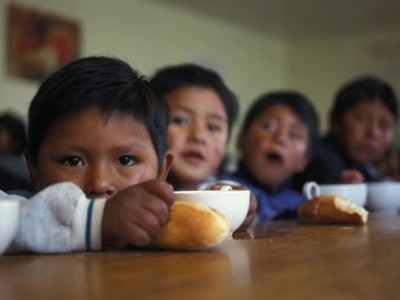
[[0, 0, 400, 152]]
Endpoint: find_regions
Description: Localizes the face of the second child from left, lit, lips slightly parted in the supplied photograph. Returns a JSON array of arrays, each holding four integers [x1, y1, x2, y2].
[[167, 87, 228, 186]]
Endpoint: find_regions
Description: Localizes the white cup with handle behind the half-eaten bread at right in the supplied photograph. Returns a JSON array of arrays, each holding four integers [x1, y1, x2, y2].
[[303, 181, 367, 207]]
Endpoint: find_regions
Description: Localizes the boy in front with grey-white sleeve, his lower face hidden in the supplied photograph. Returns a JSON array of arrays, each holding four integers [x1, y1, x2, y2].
[[0, 57, 174, 253]]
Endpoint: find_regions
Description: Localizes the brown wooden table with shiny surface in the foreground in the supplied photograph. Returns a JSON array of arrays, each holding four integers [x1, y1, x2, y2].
[[0, 215, 400, 300]]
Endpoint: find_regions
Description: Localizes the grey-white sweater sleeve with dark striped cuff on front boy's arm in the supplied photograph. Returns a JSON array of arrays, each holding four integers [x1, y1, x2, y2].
[[0, 182, 106, 253]]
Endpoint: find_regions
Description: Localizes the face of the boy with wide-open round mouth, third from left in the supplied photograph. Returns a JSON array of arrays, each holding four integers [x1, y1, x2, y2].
[[238, 104, 309, 185]]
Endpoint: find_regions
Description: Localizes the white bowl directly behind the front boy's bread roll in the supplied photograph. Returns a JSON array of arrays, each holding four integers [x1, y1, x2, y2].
[[174, 190, 250, 232]]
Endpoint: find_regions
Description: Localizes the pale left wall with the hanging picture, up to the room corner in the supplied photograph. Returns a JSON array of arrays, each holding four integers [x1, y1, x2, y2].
[[0, 0, 286, 155]]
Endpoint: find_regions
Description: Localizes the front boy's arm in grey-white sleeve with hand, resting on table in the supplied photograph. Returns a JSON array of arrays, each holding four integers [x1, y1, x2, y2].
[[2, 181, 173, 253]]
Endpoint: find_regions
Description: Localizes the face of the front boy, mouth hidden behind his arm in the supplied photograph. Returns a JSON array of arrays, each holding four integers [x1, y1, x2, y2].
[[29, 107, 169, 198]]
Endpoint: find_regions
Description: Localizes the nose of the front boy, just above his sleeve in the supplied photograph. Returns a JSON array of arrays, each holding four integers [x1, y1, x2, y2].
[[85, 164, 115, 198]]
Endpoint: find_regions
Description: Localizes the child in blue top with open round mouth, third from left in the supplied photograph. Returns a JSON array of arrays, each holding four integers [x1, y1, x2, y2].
[[225, 91, 319, 222]]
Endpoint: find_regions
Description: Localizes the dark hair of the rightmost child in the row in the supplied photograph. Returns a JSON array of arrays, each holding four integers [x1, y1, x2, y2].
[[331, 76, 398, 120]]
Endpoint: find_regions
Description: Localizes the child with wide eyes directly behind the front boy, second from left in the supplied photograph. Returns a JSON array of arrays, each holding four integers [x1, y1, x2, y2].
[[151, 64, 256, 229]]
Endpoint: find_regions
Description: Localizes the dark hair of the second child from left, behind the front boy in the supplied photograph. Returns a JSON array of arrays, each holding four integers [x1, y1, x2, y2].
[[150, 64, 239, 137]]
